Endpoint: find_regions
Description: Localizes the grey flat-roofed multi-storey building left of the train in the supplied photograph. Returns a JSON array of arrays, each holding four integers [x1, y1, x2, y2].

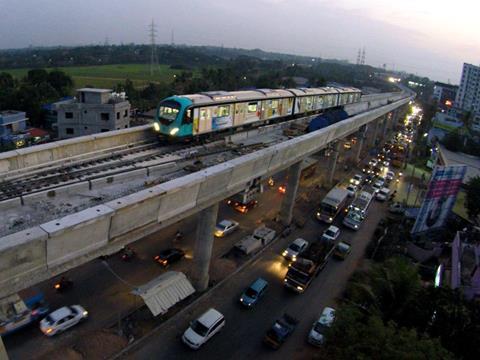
[[56, 88, 130, 139]]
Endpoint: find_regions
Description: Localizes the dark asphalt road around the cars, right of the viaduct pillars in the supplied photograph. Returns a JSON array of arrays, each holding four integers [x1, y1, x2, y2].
[[128, 190, 386, 359]]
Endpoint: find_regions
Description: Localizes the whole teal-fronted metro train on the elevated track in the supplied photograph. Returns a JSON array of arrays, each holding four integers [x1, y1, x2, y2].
[[154, 87, 361, 139]]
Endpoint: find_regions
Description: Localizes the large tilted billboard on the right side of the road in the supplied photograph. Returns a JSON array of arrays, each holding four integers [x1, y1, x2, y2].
[[412, 165, 467, 234]]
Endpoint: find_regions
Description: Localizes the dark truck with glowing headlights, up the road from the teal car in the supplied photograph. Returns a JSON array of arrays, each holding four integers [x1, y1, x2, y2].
[[283, 239, 335, 294]]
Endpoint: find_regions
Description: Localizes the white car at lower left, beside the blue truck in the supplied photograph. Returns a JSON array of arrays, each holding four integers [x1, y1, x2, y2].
[[40, 305, 88, 336]]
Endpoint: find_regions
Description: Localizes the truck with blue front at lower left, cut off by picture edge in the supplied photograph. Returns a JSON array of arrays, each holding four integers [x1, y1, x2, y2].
[[0, 293, 49, 337]]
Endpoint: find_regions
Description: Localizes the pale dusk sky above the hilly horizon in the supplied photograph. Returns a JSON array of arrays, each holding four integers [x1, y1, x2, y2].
[[0, 0, 480, 83]]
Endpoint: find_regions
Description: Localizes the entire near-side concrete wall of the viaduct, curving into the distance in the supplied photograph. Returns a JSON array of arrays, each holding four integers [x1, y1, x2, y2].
[[0, 95, 410, 298]]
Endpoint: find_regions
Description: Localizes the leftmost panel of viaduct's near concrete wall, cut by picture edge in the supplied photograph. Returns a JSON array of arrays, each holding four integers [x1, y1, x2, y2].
[[0, 226, 48, 298]]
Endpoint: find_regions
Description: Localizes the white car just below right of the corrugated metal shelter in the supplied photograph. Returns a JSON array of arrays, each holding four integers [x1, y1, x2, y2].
[[182, 308, 225, 350]]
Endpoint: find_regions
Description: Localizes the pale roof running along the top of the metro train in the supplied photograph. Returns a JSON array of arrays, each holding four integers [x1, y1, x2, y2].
[[178, 87, 360, 105]]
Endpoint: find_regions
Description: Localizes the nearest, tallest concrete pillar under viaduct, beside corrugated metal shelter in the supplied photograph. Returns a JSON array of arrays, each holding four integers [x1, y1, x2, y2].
[[192, 203, 218, 291]]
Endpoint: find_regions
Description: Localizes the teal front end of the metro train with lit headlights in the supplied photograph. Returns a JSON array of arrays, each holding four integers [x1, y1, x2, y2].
[[153, 96, 192, 138]]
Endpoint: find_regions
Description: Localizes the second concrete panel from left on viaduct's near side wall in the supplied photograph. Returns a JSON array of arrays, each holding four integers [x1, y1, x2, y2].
[[40, 205, 113, 271]]
